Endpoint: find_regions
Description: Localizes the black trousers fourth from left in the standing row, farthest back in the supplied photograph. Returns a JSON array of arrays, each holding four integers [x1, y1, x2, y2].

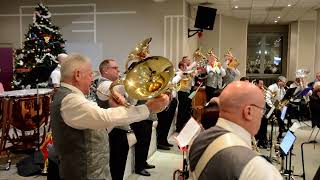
[[176, 91, 192, 132]]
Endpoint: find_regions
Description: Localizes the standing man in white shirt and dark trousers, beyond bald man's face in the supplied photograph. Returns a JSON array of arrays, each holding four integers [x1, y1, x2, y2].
[[265, 76, 287, 141]]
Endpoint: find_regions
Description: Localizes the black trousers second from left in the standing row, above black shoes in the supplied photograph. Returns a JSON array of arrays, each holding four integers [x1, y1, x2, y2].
[[130, 120, 153, 171]]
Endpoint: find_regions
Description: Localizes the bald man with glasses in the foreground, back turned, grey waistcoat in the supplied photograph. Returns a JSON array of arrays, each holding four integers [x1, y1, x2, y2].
[[189, 81, 282, 180]]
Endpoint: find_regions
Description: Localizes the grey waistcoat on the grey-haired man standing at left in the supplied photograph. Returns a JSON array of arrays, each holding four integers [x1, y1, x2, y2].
[[50, 87, 111, 180]]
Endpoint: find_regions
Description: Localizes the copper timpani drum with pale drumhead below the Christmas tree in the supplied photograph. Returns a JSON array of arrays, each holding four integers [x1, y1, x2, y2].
[[0, 88, 53, 149]]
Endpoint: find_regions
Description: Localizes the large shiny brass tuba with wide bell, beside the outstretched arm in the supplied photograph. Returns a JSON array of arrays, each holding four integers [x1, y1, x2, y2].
[[109, 38, 176, 106]]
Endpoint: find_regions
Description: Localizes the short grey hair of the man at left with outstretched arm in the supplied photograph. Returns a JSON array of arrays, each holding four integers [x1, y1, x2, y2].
[[60, 54, 91, 81]]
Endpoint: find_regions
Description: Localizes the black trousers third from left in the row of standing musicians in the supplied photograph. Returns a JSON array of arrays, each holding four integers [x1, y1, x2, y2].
[[157, 98, 178, 145]]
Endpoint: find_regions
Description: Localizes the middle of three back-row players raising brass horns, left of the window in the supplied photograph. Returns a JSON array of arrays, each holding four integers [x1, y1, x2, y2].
[[206, 50, 226, 102]]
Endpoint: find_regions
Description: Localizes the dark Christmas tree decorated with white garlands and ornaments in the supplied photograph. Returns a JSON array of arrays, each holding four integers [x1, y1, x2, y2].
[[12, 4, 65, 89]]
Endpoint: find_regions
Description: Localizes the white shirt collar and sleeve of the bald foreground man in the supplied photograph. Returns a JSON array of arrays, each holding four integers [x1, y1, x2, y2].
[[216, 118, 283, 180]]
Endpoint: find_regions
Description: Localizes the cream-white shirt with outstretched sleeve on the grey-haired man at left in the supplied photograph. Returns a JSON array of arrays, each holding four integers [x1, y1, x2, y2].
[[60, 83, 150, 129]]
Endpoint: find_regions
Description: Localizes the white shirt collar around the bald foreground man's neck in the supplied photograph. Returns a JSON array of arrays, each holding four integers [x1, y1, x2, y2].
[[216, 117, 251, 148]]
